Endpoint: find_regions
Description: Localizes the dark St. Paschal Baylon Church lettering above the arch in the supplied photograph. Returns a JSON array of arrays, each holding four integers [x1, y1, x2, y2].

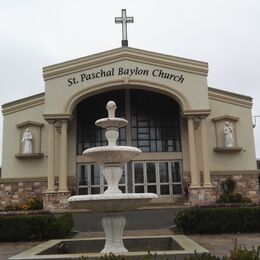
[[68, 66, 184, 87]]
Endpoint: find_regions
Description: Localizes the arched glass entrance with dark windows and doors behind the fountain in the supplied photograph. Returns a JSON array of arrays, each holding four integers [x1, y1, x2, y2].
[[76, 89, 183, 197]]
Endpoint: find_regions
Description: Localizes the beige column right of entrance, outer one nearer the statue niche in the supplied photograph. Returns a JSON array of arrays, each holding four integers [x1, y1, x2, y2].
[[200, 117, 213, 188]]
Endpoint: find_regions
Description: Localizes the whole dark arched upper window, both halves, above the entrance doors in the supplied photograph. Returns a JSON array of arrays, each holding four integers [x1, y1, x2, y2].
[[77, 90, 181, 155]]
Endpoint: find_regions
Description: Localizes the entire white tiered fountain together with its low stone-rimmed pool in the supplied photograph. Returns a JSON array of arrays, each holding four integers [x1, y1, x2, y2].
[[9, 101, 208, 260]]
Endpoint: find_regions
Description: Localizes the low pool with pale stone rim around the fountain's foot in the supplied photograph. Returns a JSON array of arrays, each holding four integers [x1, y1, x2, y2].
[[9, 235, 208, 260]]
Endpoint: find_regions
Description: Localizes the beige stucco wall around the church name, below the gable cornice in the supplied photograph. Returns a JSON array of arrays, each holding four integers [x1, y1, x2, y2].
[[44, 60, 209, 114]]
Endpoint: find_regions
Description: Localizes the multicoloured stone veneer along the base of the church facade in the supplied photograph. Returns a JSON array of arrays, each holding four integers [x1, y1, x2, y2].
[[0, 173, 260, 209]]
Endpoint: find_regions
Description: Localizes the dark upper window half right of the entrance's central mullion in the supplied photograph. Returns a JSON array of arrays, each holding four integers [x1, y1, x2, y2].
[[131, 90, 181, 152]]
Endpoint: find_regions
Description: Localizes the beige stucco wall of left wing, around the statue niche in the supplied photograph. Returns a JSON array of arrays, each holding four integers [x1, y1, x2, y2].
[[2, 104, 48, 179]]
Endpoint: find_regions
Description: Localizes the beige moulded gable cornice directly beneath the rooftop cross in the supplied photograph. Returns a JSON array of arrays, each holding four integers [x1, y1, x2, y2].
[[43, 47, 208, 80]]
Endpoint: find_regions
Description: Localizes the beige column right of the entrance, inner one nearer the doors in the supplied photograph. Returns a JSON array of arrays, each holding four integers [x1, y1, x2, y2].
[[188, 117, 201, 188]]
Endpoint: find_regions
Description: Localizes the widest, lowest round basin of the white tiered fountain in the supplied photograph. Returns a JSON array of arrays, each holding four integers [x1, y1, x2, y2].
[[69, 193, 158, 212]]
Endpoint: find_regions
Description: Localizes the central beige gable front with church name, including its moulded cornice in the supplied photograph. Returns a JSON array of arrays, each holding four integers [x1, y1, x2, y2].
[[43, 48, 209, 115]]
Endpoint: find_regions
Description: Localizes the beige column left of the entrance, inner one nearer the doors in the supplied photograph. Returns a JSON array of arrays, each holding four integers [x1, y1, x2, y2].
[[59, 120, 68, 192]]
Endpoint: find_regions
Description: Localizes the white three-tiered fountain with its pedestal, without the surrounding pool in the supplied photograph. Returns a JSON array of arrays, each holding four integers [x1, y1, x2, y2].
[[69, 101, 158, 253]]
